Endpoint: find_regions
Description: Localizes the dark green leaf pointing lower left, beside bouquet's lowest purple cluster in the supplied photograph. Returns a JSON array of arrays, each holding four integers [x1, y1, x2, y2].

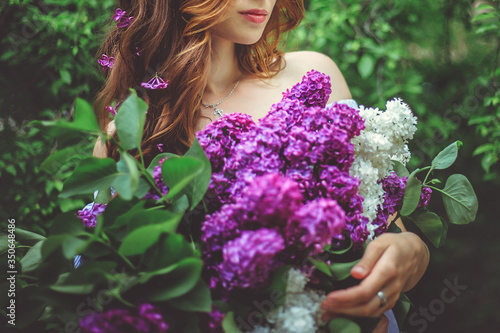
[[148, 258, 203, 302]]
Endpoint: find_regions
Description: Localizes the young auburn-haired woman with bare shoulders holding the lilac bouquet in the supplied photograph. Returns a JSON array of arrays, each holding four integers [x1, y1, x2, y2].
[[94, 0, 429, 332]]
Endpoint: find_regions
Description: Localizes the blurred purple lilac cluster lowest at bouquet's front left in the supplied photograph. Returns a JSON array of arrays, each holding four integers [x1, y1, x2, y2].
[[218, 228, 285, 290]]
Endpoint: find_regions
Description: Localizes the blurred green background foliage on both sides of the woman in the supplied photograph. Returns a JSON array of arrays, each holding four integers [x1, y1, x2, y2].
[[0, 0, 500, 333]]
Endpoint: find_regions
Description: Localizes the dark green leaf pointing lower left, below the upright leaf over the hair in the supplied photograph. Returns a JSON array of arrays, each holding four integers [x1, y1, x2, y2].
[[59, 157, 117, 198]]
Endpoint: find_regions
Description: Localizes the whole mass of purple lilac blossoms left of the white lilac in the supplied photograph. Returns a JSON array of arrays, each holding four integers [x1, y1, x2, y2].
[[197, 71, 368, 296]]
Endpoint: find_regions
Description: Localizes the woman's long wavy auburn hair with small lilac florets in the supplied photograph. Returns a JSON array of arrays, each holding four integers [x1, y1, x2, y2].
[[96, 0, 304, 163]]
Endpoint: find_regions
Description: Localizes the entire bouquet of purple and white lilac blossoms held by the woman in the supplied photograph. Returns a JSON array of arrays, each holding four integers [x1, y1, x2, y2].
[[197, 71, 438, 332]]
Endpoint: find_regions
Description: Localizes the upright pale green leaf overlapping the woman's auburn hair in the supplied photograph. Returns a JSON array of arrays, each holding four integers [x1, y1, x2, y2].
[[115, 90, 148, 150]]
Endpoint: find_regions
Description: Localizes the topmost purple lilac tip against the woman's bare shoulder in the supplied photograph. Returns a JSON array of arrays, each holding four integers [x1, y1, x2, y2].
[[283, 70, 332, 108]]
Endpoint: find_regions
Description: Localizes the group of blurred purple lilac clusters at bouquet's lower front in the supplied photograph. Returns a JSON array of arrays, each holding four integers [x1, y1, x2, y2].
[[202, 173, 345, 296]]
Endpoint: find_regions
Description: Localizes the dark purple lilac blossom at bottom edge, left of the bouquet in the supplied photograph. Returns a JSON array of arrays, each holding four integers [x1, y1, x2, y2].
[[80, 303, 169, 333]]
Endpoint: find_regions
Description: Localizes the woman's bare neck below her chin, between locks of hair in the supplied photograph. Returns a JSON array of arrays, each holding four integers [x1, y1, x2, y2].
[[205, 36, 242, 97]]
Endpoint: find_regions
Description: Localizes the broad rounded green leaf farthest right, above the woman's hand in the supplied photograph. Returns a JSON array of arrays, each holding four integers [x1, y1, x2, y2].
[[442, 174, 478, 224]]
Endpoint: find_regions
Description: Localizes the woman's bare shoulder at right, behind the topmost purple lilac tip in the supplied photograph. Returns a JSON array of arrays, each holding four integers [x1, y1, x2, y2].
[[284, 51, 352, 103]]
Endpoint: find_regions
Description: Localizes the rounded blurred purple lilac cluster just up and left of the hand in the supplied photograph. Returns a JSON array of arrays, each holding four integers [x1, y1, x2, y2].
[[286, 198, 346, 254]]
